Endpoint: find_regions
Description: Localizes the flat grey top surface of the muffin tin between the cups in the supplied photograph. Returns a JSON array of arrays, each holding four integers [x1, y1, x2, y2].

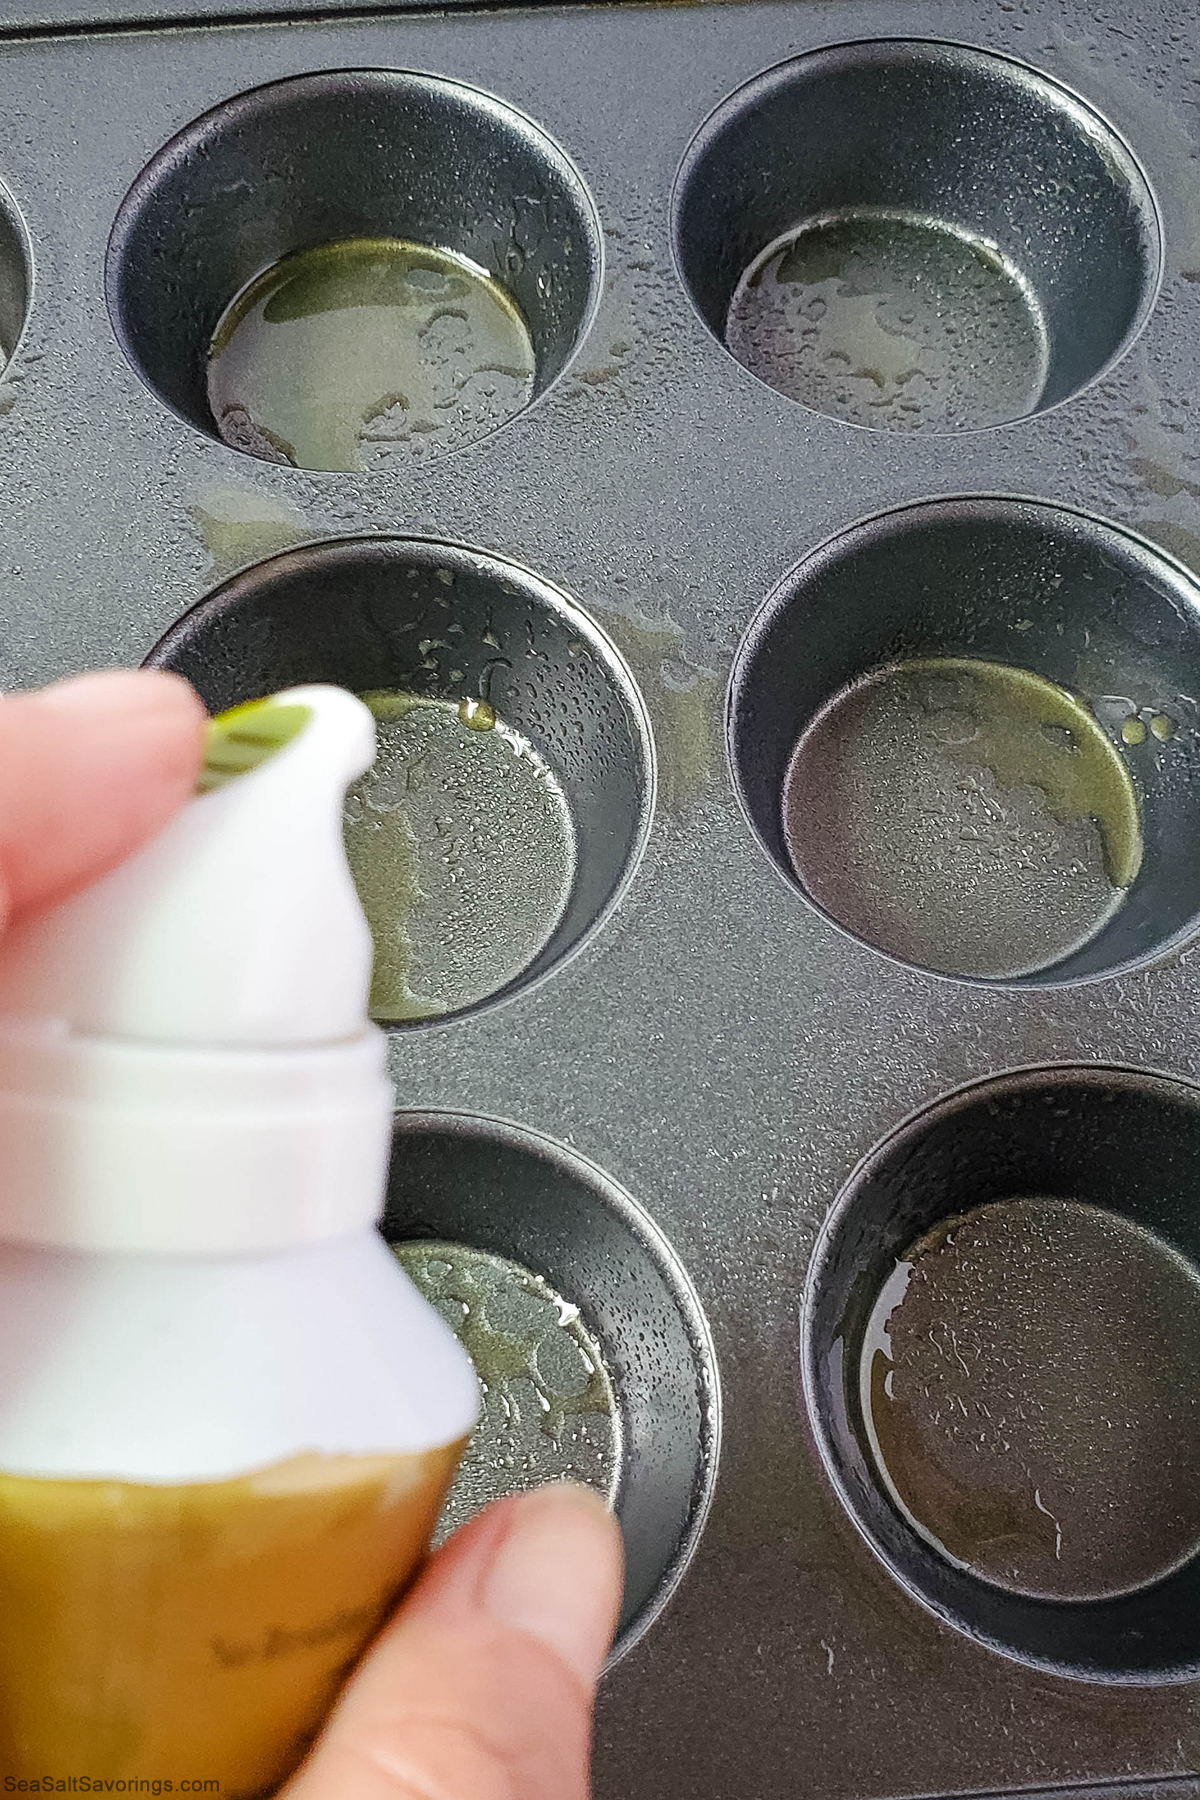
[[0, 0, 1200, 1800]]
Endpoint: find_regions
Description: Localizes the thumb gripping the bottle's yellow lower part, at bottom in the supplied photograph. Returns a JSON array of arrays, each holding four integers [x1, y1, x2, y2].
[[289, 1487, 621, 1800]]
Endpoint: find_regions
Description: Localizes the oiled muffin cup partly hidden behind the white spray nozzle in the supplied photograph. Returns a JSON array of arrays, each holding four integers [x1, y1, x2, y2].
[[149, 538, 655, 1024]]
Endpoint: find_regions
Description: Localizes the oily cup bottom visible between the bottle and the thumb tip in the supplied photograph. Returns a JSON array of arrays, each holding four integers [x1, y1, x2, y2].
[[392, 1242, 621, 1543]]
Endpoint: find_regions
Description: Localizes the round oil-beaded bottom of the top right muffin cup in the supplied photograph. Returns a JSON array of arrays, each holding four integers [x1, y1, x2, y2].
[[725, 209, 1049, 432]]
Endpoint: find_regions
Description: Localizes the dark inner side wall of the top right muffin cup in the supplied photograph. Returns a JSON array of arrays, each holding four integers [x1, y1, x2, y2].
[[675, 39, 1159, 423]]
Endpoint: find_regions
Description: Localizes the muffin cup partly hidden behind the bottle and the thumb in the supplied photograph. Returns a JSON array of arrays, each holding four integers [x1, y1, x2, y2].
[[381, 1112, 720, 1656]]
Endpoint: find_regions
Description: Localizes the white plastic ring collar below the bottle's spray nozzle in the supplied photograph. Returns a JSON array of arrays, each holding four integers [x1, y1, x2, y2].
[[0, 1021, 394, 1256]]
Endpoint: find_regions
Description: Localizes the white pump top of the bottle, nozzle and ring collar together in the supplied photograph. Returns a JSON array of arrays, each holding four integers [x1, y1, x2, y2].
[[0, 686, 392, 1255]]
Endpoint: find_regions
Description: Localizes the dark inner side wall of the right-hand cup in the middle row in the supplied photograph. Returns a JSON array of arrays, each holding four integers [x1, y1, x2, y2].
[[734, 499, 1200, 986]]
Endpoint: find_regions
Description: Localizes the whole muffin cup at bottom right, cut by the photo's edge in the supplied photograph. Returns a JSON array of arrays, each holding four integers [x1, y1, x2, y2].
[[802, 1066, 1200, 1683]]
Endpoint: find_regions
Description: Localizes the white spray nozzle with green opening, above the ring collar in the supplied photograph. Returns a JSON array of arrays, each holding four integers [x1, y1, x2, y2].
[[0, 686, 374, 1048]]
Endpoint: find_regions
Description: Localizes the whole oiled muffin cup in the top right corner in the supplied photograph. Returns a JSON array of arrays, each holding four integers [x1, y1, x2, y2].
[[673, 40, 1162, 432]]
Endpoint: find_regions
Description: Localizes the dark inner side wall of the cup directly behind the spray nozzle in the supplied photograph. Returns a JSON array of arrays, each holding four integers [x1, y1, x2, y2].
[[153, 538, 653, 1022]]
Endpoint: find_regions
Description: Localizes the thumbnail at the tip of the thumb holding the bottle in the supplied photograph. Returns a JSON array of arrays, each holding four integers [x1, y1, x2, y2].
[[480, 1485, 621, 1687]]
